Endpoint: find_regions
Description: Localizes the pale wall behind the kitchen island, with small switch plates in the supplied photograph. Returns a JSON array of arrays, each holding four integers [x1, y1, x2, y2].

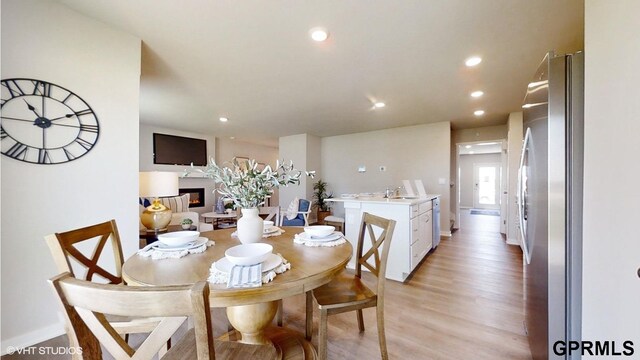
[[320, 122, 451, 233]]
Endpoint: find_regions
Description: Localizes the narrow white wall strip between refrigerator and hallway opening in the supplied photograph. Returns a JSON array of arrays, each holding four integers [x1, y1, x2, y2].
[[507, 111, 523, 245]]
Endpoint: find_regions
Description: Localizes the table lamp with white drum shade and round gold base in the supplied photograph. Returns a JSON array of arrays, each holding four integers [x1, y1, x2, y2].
[[140, 171, 178, 232]]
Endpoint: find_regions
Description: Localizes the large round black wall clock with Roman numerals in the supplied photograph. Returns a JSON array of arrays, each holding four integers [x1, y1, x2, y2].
[[0, 79, 100, 164]]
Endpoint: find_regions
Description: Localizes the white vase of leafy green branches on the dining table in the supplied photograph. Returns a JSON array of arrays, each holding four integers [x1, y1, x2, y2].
[[185, 158, 315, 243]]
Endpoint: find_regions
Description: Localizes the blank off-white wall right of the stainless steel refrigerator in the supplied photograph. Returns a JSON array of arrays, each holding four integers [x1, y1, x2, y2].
[[582, 0, 640, 348]]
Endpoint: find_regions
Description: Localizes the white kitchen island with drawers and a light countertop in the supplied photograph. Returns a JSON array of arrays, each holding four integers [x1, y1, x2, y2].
[[326, 194, 440, 282]]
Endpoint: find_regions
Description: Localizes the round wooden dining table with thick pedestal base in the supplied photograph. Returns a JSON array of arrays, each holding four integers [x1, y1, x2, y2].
[[122, 227, 353, 358]]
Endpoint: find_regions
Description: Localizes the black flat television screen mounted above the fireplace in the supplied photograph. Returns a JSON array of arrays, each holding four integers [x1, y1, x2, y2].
[[153, 133, 207, 166]]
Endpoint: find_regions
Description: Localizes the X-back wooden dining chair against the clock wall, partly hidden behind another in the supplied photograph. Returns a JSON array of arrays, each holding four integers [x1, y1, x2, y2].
[[45, 220, 171, 355]]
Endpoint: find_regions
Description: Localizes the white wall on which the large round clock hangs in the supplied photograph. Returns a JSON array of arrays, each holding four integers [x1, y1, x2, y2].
[[0, 0, 140, 352]]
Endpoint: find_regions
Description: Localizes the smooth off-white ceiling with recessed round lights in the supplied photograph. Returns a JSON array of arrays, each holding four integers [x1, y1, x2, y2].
[[59, 0, 584, 146]]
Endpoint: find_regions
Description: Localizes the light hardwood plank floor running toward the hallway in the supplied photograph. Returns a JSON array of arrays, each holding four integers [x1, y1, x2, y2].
[[2, 211, 531, 360]]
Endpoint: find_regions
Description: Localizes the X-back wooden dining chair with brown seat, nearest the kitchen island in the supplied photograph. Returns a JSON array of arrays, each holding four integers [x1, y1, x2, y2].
[[305, 212, 396, 359]]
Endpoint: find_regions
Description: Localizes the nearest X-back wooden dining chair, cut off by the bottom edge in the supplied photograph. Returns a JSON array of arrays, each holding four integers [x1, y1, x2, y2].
[[49, 272, 276, 360]]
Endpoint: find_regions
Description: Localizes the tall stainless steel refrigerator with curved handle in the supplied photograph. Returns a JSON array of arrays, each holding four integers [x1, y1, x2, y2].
[[518, 52, 584, 360]]
